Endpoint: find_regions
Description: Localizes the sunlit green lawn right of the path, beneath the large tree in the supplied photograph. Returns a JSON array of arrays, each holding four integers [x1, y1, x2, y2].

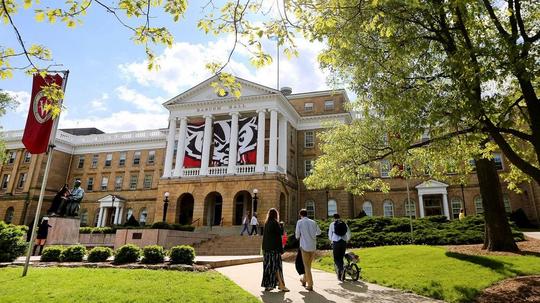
[[314, 245, 540, 302]]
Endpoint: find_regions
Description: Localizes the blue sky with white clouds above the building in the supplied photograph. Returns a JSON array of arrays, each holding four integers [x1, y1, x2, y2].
[[0, 1, 342, 132]]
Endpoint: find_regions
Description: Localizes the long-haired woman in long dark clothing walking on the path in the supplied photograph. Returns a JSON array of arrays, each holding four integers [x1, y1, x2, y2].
[[261, 208, 289, 292]]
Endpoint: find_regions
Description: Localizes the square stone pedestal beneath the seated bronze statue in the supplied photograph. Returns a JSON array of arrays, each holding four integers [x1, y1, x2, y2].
[[47, 217, 81, 245]]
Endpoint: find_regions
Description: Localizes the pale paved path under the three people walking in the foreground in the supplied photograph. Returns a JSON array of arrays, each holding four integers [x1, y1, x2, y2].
[[216, 262, 441, 303]]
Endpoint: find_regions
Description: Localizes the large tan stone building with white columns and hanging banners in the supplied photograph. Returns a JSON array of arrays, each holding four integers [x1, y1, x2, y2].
[[0, 78, 540, 226]]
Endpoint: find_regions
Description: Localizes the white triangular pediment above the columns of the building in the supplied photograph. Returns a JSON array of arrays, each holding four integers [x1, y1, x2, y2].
[[163, 75, 281, 107]]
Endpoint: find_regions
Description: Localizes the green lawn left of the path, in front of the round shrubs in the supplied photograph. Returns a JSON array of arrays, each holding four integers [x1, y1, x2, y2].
[[0, 267, 258, 303]]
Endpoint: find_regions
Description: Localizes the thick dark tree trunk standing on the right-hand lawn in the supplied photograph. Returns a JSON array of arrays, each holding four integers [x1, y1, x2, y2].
[[476, 158, 519, 252]]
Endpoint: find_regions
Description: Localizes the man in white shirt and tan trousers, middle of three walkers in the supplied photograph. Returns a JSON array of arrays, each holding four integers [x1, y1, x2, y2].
[[295, 209, 321, 290]]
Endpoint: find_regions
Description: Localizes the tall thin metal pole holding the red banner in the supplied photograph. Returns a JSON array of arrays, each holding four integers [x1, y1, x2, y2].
[[22, 70, 69, 277]]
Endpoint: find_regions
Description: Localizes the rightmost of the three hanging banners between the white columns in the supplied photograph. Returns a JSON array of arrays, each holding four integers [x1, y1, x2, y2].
[[237, 117, 257, 164]]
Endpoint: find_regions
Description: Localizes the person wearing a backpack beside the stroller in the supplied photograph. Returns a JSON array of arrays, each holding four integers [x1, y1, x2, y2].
[[328, 214, 351, 281]]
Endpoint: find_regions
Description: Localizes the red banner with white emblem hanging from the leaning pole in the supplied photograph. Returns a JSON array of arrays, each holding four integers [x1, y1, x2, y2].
[[22, 74, 63, 154]]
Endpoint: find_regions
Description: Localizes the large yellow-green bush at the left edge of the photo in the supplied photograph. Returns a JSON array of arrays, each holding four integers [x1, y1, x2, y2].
[[0, 221, 28, 262]]
